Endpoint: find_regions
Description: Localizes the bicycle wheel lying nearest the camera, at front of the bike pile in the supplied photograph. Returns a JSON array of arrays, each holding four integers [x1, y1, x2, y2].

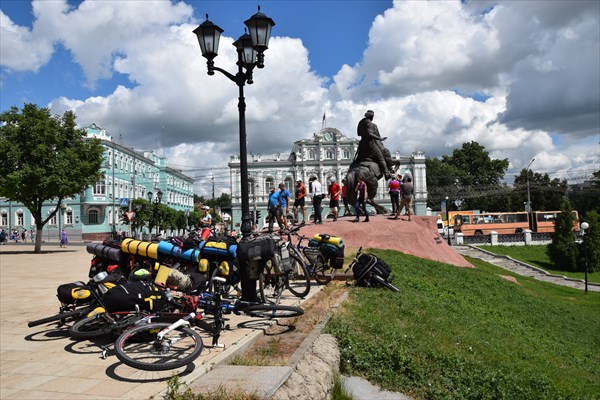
[[115, 322, 204, 371]]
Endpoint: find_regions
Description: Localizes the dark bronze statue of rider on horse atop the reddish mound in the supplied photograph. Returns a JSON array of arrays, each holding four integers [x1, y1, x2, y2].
[[346, 110, 400, 214]]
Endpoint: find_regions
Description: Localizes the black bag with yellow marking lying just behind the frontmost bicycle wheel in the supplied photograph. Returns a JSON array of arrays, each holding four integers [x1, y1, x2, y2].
[[102, 282, 164, 312]]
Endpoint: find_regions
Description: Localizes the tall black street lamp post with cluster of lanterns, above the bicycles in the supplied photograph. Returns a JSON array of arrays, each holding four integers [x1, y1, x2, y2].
[[194, 6, 275, 237]]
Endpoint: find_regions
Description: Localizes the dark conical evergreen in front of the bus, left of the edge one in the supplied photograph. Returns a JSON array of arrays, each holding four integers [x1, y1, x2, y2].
[[548, 200, 578, 271]]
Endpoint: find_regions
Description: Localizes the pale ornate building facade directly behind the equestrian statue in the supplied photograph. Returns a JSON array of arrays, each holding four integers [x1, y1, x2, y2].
[[228, 128, 427, 229]]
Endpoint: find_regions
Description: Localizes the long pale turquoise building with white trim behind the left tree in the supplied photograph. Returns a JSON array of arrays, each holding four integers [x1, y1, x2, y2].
[[0, 124, 194, 241]]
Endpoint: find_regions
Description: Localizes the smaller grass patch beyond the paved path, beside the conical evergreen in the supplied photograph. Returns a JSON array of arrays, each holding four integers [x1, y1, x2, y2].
[[479, 245, 600, 283]]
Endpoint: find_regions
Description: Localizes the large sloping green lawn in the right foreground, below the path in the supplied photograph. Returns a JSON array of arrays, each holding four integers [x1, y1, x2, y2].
[[326, 250, 600, 400]]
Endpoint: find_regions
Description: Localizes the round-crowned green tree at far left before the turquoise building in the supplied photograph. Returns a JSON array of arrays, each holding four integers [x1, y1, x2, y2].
[[0, 104, 104, 253]]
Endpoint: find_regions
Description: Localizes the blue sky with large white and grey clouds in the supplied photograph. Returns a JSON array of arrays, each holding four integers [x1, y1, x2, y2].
[[0, 0, 600, 195]]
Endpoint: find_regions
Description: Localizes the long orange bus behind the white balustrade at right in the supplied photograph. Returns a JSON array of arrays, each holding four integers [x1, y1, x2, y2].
[[454, 211, 579, 236]]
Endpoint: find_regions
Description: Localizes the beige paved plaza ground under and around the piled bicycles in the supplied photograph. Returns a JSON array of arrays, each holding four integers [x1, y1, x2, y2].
[[0, 244, 318, 400]]
